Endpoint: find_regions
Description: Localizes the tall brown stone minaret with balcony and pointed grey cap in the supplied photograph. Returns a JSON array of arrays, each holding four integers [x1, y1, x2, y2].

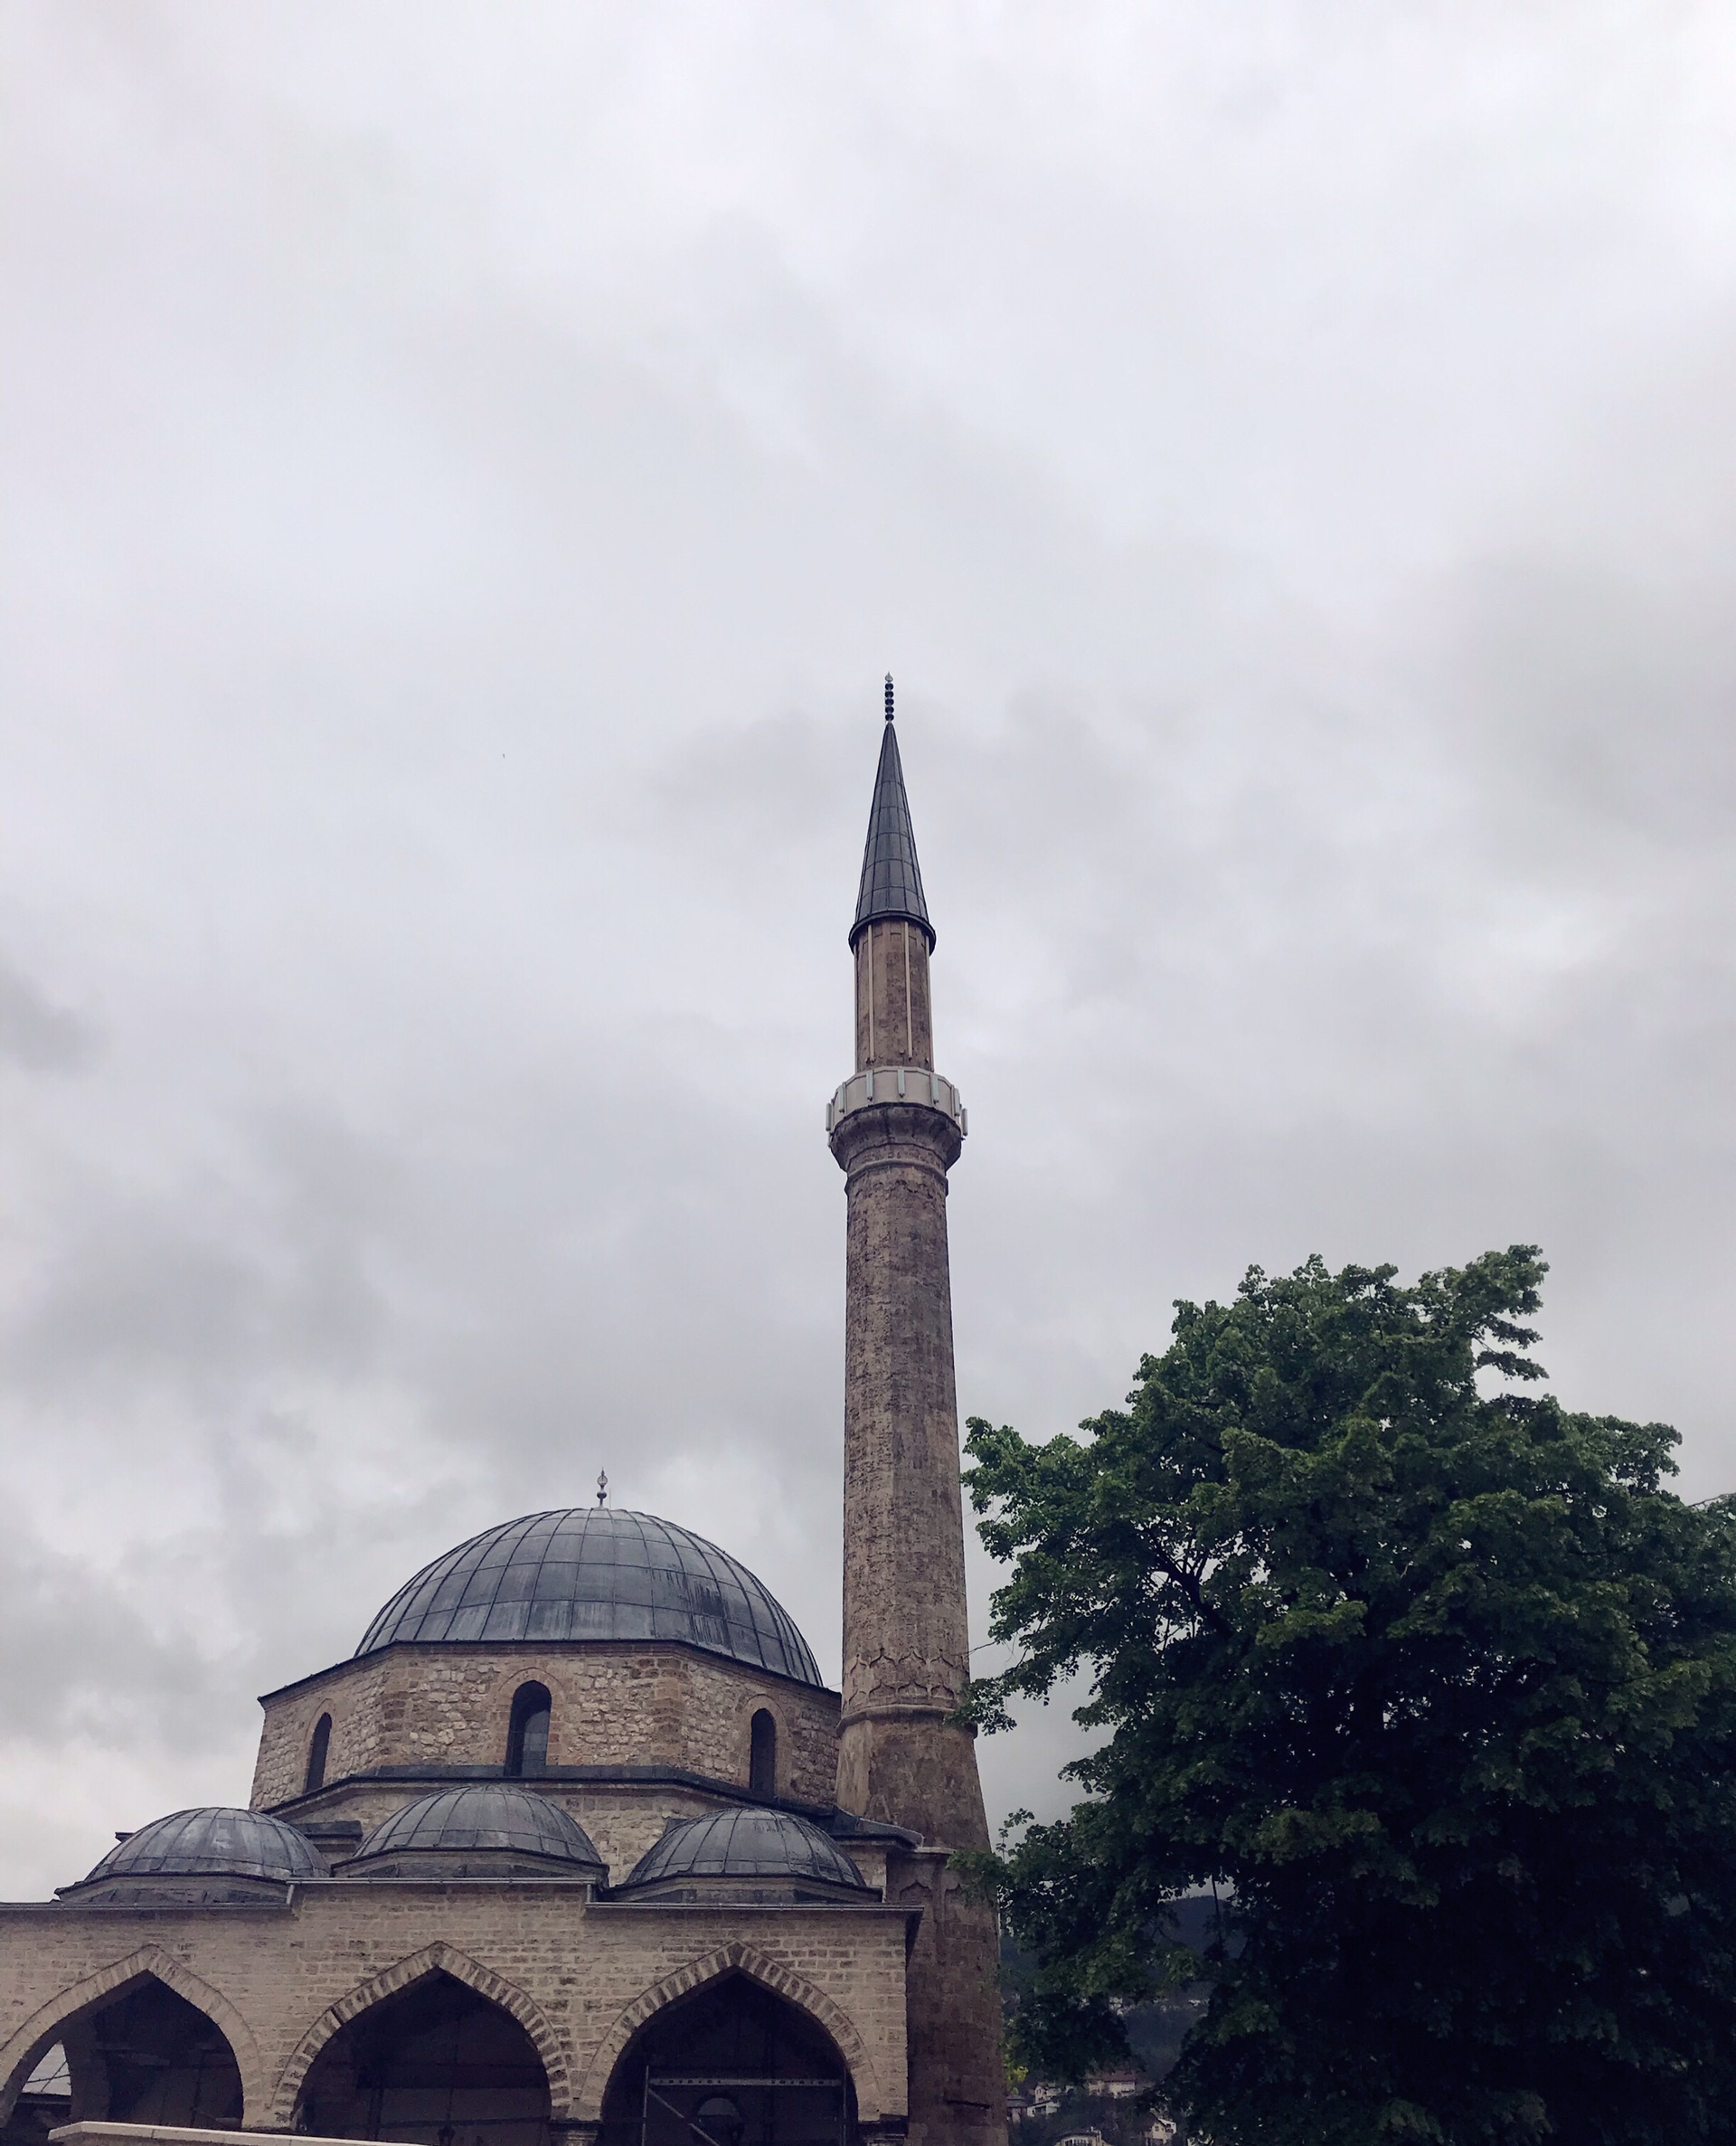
[[826, 678, 1006, 2141]]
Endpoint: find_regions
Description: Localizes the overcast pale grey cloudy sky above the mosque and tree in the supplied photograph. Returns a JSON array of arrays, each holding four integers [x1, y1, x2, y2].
[[0, 0, 1736, 1897]]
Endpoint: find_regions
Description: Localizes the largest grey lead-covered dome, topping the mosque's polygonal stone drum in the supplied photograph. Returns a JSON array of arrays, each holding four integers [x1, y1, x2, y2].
[[356, 1504, 820, 1685]]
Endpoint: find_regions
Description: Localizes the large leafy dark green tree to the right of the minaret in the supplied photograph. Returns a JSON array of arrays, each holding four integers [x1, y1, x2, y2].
[[966, 1244, 1736, 2146]]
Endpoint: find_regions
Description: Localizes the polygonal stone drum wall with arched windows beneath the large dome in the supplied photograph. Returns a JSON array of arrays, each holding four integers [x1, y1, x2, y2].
[[251, 1641, 839, 1816]]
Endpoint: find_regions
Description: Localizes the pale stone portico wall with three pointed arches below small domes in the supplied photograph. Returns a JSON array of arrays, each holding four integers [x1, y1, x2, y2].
[[0, 1882, 906, 2129]]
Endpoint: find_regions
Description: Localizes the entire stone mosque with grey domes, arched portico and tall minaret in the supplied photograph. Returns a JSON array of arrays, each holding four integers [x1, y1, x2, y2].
[[0, 678, 1006, 2146]]
